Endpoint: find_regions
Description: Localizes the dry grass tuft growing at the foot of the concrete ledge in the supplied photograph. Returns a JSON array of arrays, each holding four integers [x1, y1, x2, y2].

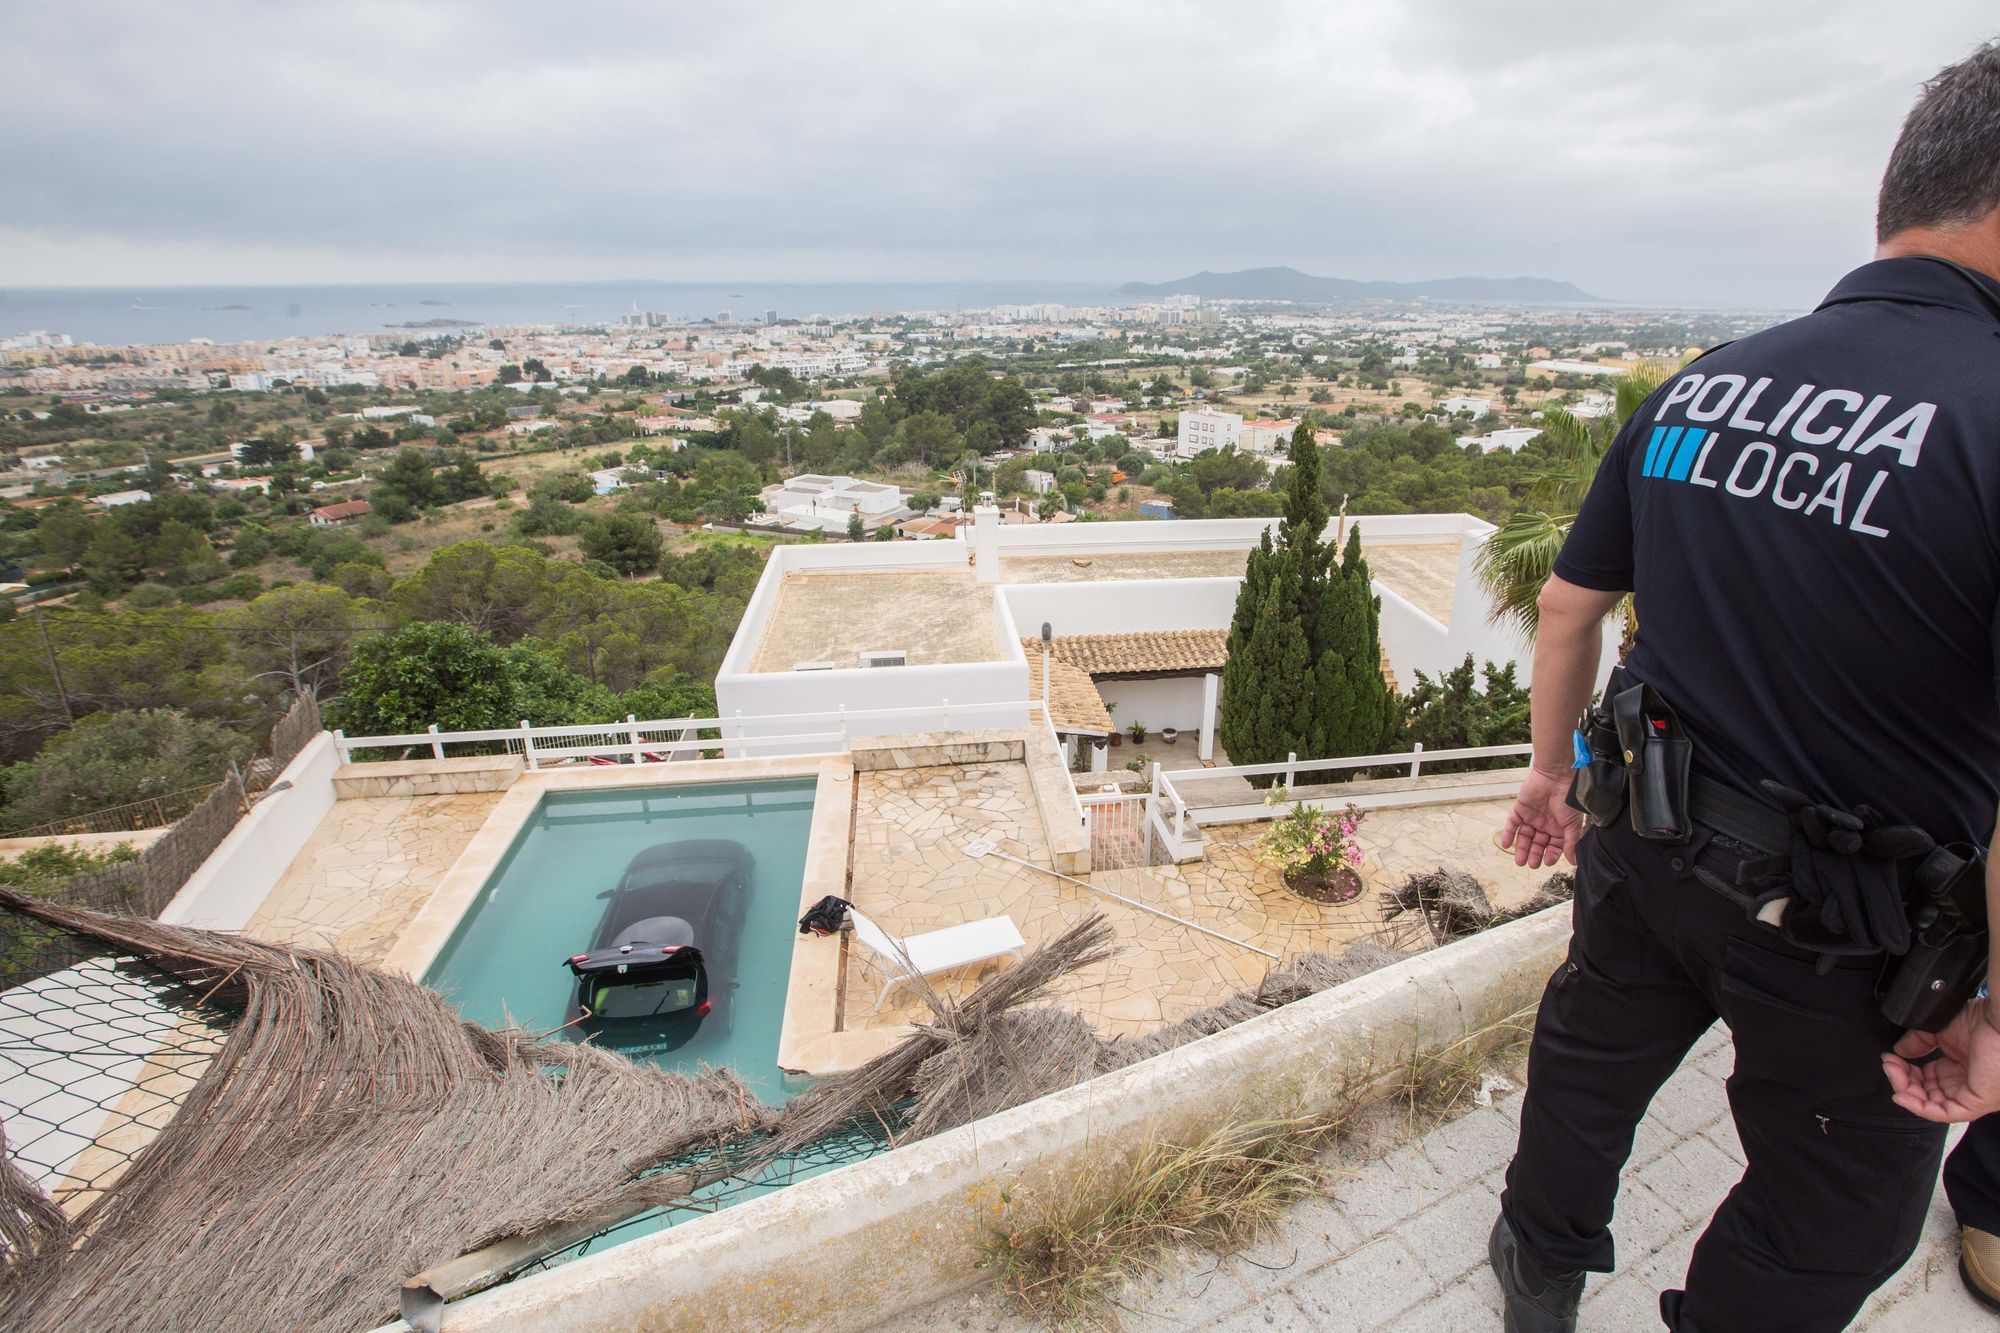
[[980, 1115, 1346, 1327]]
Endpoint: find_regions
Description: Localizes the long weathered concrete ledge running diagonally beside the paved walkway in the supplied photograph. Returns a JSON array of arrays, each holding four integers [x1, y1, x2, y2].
[[430, 896, 1570, 1333]]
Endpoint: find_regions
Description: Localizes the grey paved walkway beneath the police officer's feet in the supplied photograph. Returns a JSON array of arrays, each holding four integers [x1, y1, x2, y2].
[[884, 1029, 2000, 1333]]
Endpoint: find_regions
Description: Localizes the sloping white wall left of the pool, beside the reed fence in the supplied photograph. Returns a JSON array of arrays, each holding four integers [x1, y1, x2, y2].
[[160, 731, 340, 931]]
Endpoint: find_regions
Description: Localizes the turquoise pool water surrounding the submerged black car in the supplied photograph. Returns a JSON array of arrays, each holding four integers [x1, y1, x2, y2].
[[424, 779, 814, 1105]]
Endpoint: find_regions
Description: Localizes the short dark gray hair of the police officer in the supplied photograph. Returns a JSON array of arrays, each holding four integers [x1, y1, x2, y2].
[[1876, 42, 2000, 240]]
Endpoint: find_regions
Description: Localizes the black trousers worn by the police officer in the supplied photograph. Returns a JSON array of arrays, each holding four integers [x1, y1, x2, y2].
[[1500, 827, 1944, 1333]]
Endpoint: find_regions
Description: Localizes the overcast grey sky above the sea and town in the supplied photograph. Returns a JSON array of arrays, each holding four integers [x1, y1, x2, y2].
[[0, 0, 2000, 306]]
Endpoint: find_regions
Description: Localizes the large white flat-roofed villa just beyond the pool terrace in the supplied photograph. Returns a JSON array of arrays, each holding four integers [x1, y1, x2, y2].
[[716, 498, 1616, 769]]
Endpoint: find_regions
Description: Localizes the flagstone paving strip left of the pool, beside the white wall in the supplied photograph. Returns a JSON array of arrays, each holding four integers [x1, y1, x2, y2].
[[244, 791, 500, 963]]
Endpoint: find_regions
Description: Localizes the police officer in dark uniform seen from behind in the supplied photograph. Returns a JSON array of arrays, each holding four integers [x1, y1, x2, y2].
[[1490, 44, 2000, 1331]]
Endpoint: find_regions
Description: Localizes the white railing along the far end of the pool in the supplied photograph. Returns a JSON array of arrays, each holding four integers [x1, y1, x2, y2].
[[334, 699, 1040, 768]]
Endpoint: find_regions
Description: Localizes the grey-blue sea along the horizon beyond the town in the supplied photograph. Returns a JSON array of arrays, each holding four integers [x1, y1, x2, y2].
[[0, 280, 1132, 346]]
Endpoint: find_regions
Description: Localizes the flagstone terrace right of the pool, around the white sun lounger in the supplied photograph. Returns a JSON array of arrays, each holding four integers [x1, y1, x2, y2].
[[844, 763, 1542, 1037]]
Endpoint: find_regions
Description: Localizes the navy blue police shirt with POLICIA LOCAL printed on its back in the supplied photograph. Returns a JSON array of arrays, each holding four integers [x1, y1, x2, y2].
[[1556, 258, 2000, 847]]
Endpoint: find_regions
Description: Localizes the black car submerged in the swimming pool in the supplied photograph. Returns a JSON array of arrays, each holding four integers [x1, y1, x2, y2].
[[568, 839, 754, 1051]]
